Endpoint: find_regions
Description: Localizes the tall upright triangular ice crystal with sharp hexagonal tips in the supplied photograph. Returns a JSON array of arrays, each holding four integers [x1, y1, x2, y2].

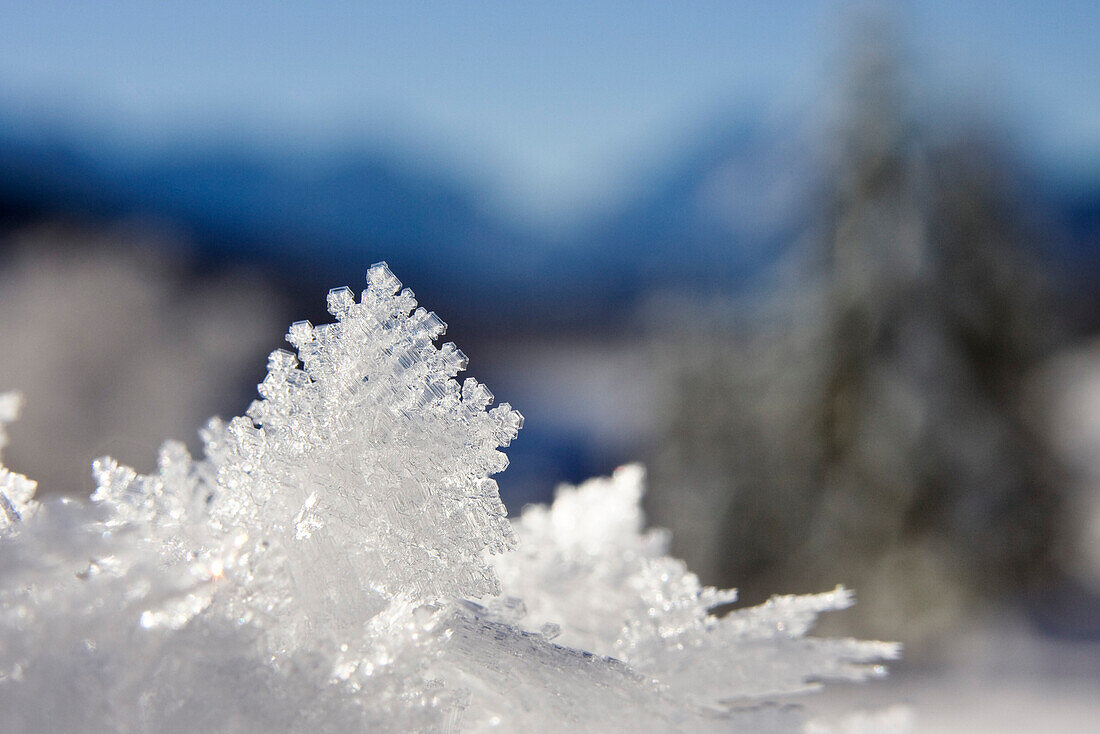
[[229, 263, 521, 607]]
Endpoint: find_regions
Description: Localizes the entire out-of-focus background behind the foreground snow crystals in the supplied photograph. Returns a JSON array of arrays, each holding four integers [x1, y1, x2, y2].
[[0, 0, 1100, 732]]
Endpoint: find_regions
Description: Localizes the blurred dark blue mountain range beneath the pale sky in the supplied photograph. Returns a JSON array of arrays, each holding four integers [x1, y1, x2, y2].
[[0, 113, 1100, 336]]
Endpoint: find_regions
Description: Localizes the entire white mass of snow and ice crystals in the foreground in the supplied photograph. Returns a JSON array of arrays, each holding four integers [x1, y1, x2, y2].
[[0, 264, 898, 734]]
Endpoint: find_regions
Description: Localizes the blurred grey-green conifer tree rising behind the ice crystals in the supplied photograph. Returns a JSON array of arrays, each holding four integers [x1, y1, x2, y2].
[[650, 20, 1059, 640]]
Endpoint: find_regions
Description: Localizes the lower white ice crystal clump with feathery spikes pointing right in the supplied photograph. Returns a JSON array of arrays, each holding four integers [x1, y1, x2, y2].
[[497, 465, 897, 705]]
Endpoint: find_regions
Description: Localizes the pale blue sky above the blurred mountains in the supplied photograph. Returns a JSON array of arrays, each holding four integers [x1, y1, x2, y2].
[[0, 0, 1100, 222]]
